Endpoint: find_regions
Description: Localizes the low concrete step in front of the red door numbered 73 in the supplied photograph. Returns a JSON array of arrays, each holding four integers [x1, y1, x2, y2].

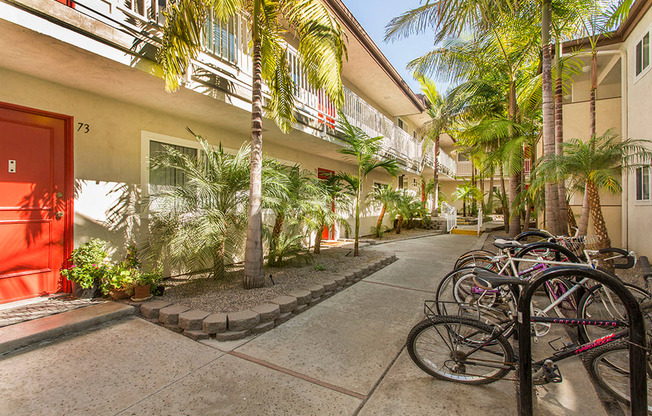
[[0, 302, 135, 355]]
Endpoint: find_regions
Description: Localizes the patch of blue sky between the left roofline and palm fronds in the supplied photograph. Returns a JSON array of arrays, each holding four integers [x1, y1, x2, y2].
[[343, 0, 446, 93]]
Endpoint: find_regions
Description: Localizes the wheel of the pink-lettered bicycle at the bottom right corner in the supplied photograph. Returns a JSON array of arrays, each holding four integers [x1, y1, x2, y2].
[[585, 341, 652, 414]]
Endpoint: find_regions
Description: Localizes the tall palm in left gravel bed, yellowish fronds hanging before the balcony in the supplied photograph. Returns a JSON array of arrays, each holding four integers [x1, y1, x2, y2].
[[158, 0, 346, 288]]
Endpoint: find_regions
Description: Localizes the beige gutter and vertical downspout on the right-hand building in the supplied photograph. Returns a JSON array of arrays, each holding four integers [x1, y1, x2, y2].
[[562, 49, 629, 250]]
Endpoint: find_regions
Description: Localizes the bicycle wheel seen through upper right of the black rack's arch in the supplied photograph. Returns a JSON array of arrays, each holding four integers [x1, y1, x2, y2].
[[577, 283, 652, 343]]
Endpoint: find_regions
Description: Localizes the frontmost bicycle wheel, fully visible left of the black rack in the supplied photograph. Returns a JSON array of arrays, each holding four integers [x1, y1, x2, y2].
[[407, 316, 514, 384]]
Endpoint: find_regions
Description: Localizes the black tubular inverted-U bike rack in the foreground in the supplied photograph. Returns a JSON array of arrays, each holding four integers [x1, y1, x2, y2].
[[518, 266, 647, 416]]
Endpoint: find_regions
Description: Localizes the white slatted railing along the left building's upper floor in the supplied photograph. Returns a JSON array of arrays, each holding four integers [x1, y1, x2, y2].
[[52, 0, 432, 171]]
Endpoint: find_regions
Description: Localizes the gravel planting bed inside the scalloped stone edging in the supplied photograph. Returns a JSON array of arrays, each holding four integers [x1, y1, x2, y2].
[[156, 247, 384, 312]]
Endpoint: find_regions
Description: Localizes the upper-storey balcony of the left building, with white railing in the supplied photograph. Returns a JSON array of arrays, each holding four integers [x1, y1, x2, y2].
[[44, 0, 432, 171]]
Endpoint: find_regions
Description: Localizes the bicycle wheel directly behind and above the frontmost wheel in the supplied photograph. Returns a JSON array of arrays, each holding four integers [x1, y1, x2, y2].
[[435, 267, 516, 337]]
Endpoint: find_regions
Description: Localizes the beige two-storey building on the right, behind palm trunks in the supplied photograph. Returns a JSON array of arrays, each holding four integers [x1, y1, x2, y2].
[[563, 0, 652, 256]]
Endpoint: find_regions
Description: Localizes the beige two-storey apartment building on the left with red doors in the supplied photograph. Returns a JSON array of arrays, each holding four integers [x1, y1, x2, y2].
[[0, 0, 455, 302]]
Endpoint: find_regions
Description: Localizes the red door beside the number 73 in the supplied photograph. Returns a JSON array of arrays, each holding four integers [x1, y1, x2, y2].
[[0, 103, 73, 303]]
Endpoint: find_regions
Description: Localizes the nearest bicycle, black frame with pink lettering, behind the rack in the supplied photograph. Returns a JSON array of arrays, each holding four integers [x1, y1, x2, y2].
[[406, 269, 652, 411]]
